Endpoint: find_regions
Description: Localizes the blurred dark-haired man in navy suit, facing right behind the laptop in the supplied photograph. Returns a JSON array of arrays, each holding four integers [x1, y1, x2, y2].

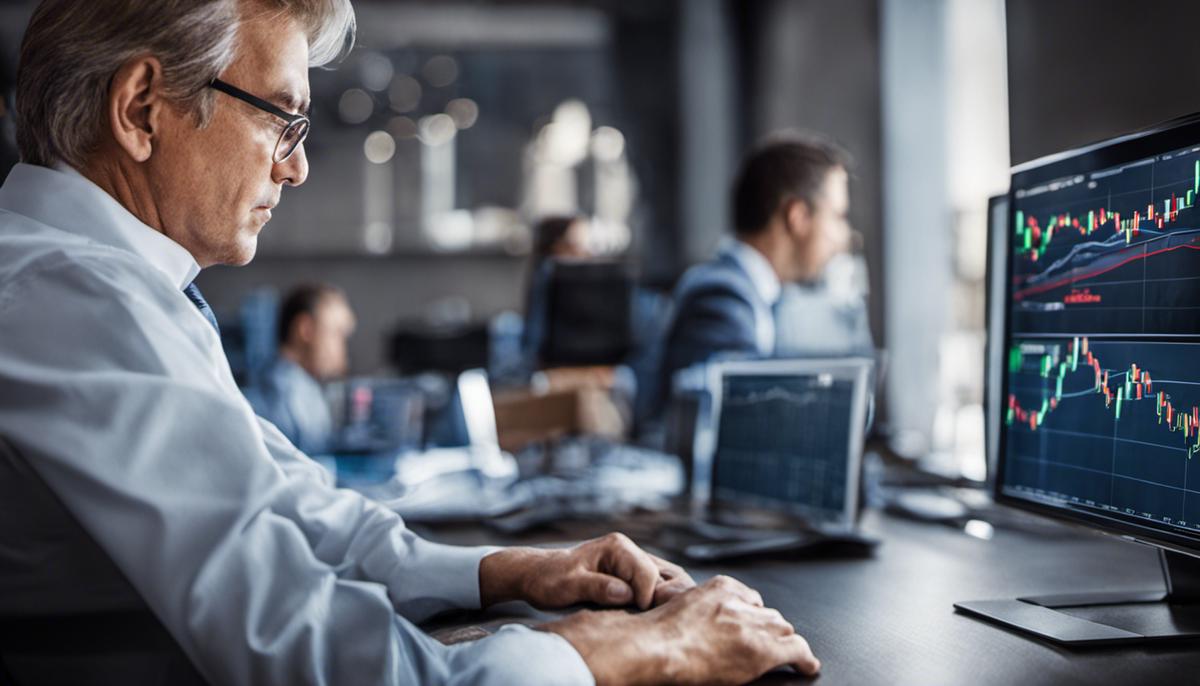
[[659, 137, 852, 410]]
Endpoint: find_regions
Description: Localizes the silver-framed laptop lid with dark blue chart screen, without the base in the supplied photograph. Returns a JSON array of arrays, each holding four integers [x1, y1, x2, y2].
[[709, 357, 872, 530]]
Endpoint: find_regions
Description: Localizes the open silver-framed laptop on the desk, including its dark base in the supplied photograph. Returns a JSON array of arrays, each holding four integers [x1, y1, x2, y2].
[[666, 357, 875, 560]]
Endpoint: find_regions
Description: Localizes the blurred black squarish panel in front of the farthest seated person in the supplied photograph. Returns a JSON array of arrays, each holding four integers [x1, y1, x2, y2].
[[540, 260, 634, 366]]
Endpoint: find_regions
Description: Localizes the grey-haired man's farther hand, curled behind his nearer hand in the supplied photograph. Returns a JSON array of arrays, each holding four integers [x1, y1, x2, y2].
[[479, 534, 696, 609]]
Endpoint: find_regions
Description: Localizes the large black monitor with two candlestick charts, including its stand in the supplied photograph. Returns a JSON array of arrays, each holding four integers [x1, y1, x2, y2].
[[955, 115, 1200, 644]]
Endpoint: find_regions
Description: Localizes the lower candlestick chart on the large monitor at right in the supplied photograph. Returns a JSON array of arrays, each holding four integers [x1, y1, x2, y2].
[[1003, 338, 1200, 525]]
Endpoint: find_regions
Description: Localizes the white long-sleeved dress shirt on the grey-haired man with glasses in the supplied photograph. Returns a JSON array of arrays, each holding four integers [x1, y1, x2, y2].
[[0, 164, 592, 684]]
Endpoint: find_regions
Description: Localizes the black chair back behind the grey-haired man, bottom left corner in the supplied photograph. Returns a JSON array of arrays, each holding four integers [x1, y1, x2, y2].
[[0, 438, 205, 686]]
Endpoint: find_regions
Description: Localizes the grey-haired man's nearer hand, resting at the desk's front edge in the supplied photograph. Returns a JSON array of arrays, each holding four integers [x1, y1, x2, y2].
[[540, 577, 821, 686]]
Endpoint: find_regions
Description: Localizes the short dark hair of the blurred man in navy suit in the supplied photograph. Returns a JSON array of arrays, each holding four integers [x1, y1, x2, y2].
[[732, 134, 851, 235]]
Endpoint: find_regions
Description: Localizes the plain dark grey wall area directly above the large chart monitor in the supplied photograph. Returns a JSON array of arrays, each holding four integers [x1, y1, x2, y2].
[[1007, 0, 1200, 164]]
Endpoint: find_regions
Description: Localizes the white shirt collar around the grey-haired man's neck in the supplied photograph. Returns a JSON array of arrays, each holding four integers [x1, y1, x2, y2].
[[0, 163, 200, 290]]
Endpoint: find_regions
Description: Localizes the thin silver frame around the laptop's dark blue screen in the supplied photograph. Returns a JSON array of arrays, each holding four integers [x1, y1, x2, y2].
[[706, 357, 875, 531]]
